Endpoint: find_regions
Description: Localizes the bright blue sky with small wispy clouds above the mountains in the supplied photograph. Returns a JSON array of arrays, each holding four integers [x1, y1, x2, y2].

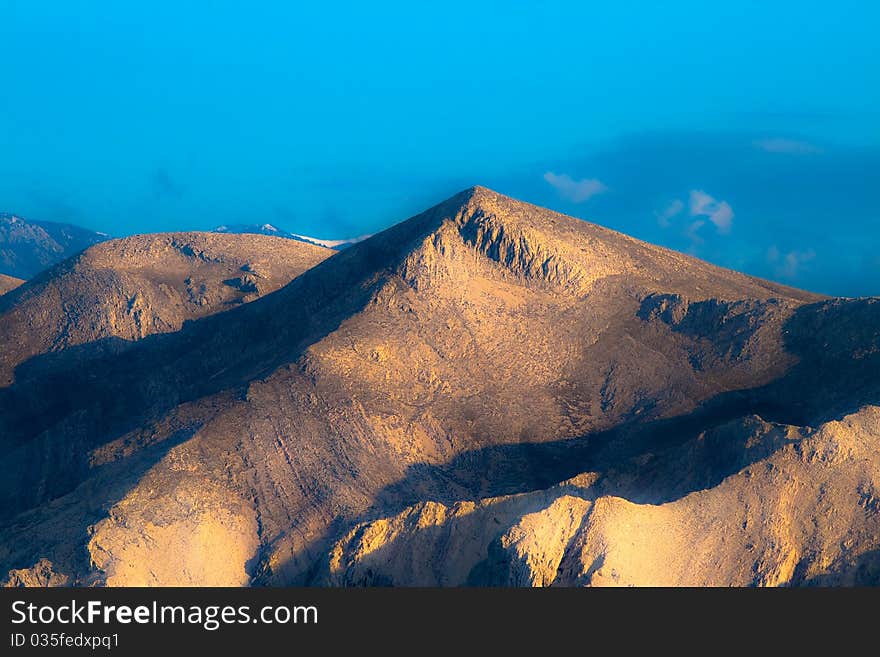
[[0, 0, 880, 295]]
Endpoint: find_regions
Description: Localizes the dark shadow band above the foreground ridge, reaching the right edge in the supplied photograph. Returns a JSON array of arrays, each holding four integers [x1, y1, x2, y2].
[[290, 299, 880, 585]]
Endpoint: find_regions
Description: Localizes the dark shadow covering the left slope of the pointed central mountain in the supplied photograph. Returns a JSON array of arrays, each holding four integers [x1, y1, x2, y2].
[[0, 245, 388, 524]]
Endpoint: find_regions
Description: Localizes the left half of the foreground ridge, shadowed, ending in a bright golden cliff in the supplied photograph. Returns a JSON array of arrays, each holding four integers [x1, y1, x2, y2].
[[322, 475, 595, 586]]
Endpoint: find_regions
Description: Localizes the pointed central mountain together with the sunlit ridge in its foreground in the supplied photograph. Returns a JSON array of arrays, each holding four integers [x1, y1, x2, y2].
[[0, 187, 880, 585]]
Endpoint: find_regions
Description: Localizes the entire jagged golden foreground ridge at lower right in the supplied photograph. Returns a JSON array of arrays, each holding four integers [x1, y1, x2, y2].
[[324, 406, 880, 586]]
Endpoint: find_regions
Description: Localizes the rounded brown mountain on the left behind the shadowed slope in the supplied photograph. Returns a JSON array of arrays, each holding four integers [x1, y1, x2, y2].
[[0, 233, 333, 384]]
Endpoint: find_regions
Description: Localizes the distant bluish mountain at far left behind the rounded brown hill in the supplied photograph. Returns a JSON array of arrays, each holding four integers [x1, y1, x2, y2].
[[0, 213, 109, 278]]
